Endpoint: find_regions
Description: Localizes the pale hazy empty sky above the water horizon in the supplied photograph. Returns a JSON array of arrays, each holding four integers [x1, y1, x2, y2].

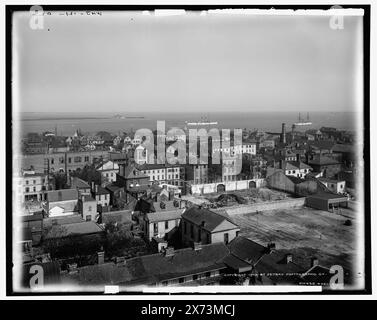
[[13, 12, 362, 112]]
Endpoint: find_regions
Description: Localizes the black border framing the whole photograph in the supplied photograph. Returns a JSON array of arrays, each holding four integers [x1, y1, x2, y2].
[[5, 4, 372, 296]]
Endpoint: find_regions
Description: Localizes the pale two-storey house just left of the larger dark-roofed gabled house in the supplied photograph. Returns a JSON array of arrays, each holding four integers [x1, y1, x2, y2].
[[143, 209, 183, 241]]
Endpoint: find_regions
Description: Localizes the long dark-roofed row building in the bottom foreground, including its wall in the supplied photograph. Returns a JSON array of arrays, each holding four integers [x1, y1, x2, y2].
[[63, 243, 229, 290]]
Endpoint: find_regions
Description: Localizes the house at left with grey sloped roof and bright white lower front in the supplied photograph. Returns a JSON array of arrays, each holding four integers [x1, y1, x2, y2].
[[45, 189, 79, 217]]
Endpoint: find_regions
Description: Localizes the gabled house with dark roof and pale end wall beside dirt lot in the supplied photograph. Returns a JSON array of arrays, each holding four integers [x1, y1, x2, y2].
[[181, 206, 240, 245]]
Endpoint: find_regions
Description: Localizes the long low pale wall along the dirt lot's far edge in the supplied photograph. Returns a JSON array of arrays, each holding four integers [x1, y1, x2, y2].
[[214, 197, 305, 216]]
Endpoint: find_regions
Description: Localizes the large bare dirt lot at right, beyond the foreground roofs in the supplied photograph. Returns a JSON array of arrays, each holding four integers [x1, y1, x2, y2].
[[232, 207, 359, 282]]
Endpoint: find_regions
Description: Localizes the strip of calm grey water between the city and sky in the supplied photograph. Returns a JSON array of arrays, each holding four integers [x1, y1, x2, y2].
[[15, 112, 356, 136]]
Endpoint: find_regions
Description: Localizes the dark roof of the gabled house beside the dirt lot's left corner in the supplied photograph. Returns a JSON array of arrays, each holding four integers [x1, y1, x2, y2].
[[182, 206, 238, 231]]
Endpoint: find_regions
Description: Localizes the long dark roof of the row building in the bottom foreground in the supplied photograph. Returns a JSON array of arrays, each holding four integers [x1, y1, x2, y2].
[[66, 243, 229, 285]]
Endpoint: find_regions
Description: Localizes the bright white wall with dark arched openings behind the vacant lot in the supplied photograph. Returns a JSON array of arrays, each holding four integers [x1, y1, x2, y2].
[[191, 179, 266, 194]]
